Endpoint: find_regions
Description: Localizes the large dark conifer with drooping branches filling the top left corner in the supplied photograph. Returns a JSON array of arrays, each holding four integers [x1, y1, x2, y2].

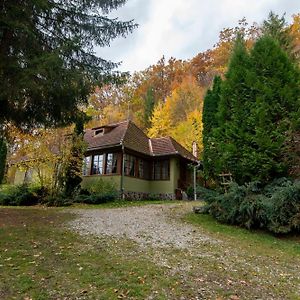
[[0, 0, 135, 129]]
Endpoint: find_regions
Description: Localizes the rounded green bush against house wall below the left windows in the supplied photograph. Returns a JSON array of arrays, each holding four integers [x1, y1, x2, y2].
[[75, 178, 119, 204]]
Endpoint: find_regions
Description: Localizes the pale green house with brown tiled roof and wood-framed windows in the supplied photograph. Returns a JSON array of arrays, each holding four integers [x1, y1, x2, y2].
[[82, 121, 197, 199]]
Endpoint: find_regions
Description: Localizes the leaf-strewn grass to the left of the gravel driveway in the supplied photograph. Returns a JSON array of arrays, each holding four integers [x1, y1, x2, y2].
[[0, 208, 185, 299]]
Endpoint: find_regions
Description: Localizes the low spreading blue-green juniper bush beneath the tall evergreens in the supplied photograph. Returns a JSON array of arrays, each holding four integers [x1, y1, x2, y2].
[[206, 178, 300, 233]]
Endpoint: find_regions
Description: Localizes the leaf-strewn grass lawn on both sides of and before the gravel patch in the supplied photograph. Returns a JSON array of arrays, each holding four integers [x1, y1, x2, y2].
[[0, 202, 300, 300]]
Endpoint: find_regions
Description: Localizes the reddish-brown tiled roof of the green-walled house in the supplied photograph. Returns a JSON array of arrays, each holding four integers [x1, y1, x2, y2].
[[84, 121, 197, 161]]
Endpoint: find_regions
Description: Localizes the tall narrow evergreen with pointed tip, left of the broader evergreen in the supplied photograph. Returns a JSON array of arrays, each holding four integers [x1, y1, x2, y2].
[[213, 36, 252, 182]]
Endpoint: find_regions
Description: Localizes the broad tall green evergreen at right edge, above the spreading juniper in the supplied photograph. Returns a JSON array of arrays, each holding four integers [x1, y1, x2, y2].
[[248, 36, 300, 182]]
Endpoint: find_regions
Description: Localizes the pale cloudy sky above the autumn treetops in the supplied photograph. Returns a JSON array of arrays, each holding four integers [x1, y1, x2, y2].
[[97, 0, 300, 72]]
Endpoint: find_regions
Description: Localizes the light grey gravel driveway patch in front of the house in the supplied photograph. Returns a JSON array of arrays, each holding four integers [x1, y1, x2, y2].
[[70, 205, 217, 248]]
